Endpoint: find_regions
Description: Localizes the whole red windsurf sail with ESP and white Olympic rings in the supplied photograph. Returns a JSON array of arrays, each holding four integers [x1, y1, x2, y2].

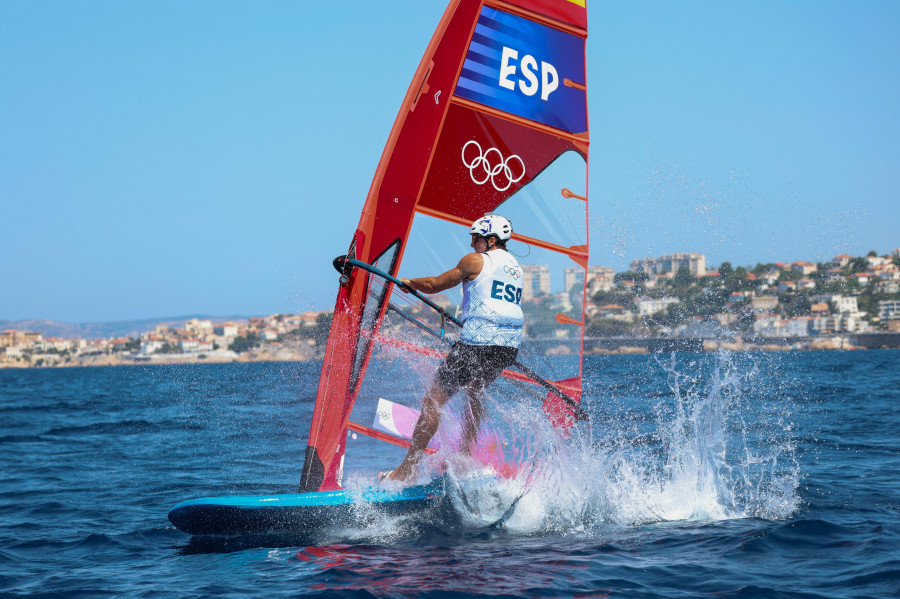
[[300, 0, 589, 491]]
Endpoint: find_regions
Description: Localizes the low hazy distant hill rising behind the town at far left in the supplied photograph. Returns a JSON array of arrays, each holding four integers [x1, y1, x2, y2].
[[0, 315, 247, 339]]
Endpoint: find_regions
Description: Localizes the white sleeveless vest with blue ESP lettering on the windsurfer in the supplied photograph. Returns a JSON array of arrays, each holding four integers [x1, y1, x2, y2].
[[460, 249, 525, 347]]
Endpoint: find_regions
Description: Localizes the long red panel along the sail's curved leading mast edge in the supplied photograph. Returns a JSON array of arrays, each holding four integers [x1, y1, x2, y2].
[[300, 0, 481, 491]]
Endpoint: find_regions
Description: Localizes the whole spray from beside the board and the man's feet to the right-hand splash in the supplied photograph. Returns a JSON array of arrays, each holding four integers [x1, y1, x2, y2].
[[347, 351, 800, 542]]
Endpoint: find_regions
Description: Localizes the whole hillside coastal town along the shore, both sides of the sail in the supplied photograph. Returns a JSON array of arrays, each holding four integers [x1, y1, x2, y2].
[[0, 249, 900, 368]]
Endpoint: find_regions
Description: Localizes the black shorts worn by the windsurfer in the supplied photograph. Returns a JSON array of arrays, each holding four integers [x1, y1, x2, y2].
[[434, 341, 519, 395]]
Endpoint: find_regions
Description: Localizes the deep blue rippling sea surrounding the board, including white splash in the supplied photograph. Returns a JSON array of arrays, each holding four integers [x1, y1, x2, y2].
[[0, 350, 900, 598]]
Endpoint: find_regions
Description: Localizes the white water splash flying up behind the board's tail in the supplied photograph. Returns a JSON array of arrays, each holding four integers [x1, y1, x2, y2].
[[426, 352, 800, 534]]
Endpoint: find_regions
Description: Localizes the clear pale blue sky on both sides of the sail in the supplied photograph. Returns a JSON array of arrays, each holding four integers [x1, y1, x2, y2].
[[0, 0, 900, 322]]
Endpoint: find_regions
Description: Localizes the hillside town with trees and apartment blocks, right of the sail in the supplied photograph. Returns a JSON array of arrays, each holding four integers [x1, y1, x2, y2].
[[568, 250, 900, 338]]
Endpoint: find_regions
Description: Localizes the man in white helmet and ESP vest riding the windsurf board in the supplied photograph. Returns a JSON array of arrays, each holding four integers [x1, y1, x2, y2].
[[383, 214, 524, 481]]
